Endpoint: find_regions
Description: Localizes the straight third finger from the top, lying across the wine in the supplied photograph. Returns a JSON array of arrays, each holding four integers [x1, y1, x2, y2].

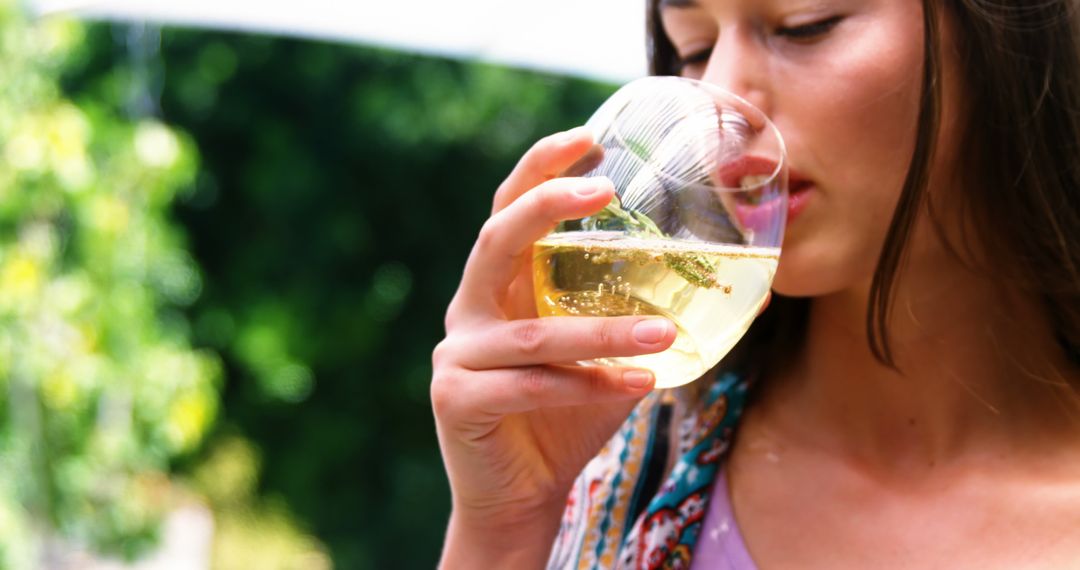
[[451, 316, 676, 370]]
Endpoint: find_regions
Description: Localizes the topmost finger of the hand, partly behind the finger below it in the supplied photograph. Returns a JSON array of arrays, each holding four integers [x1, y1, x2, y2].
[[491, 126, 593, 214]]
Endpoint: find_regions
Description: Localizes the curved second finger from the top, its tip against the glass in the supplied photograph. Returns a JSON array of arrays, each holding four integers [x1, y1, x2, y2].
[[451, 177, 615, 316]]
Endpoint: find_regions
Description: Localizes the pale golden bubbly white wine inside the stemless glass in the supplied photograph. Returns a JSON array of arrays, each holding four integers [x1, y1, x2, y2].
[[532, 231, 780, 388]]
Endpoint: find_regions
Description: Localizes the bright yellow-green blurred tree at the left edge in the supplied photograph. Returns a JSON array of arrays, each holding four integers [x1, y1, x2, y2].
[[0, 0, 221, 568]]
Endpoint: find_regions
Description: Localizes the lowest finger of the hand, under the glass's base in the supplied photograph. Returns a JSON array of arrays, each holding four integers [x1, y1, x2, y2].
[[431, 366, 656, 419]]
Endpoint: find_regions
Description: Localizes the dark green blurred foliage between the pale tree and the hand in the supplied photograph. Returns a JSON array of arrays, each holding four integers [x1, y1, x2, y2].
[[56, 19, 613, 568]]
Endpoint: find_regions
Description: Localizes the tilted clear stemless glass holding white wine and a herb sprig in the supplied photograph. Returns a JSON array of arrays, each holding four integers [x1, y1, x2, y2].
[[534, 77, 787, 388]]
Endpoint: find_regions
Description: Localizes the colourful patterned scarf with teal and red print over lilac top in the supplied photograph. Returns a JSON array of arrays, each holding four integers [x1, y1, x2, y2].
[[548, 372, 747, 570]]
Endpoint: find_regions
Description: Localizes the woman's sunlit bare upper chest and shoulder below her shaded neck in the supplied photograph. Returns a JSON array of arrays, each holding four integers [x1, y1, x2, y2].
[[729, 395, 1080, 569]]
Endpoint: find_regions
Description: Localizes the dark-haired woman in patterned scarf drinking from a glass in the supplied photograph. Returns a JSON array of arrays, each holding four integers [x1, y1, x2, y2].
[[432, 0, 1080, 568]]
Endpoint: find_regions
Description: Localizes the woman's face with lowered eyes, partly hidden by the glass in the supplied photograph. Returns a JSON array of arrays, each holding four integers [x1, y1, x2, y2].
[[661, 0, 950, 296]]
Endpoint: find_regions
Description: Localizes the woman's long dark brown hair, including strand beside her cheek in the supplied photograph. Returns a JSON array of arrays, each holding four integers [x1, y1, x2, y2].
[[646, 0, 1080, 382]]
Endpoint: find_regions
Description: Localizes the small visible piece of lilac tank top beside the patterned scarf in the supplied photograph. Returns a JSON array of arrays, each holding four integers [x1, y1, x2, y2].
[[690, 466, 757, 570]]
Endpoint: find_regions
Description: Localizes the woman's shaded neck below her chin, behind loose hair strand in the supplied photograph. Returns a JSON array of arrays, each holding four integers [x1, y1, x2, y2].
[[771, 260, 1080, 472]]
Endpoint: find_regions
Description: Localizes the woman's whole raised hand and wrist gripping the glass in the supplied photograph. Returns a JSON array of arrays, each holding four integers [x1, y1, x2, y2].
[[431, 128, 675, 568]]
